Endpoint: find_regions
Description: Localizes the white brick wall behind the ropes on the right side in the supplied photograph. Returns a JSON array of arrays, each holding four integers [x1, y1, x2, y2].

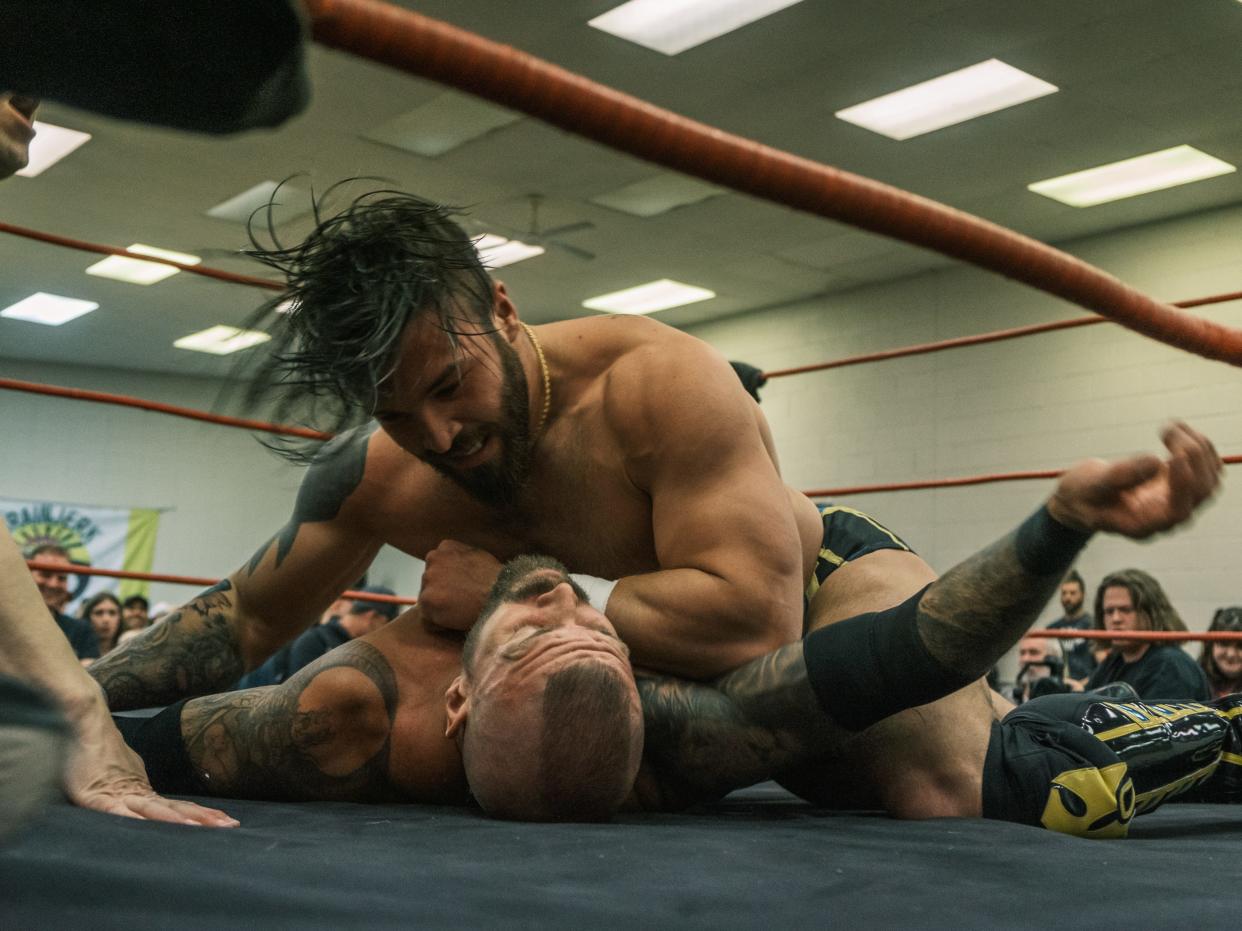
[[691, 202, 1242, 672]]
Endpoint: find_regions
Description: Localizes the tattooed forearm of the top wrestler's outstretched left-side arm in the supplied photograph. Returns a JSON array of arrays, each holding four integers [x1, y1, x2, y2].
[[88, 580, 243, 711]]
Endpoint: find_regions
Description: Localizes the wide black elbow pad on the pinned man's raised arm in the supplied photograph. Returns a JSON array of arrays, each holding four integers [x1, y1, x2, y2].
[[802, 588, 974, 731]]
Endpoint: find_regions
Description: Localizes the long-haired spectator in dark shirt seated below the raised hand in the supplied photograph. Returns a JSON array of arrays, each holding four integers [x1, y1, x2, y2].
[[1087, 569, 1210, 701]]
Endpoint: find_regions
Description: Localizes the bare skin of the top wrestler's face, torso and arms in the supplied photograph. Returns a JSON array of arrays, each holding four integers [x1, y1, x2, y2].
[[92, 310, 822, 709]]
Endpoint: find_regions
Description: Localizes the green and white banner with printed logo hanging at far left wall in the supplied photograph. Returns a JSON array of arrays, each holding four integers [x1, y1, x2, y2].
[[0, 498, 159, 613]]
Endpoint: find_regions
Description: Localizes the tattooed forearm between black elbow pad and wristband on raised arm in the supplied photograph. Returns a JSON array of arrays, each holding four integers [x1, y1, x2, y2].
[[918, 531, 1062, 677]]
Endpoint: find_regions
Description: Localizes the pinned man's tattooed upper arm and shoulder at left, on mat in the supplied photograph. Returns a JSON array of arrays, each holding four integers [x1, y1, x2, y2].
[[181, 641, 397, 802]]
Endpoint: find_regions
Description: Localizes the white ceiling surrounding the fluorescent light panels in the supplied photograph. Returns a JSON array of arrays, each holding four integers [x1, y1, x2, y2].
[[0, 0, 1242, 375]]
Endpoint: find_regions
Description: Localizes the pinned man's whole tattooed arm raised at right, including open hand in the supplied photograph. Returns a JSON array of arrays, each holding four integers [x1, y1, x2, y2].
[[638, 425, 1220, 807]]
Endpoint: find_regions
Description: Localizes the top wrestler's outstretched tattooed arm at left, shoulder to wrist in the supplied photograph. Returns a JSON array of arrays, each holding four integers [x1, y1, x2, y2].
[[89, 425, 380, 710]]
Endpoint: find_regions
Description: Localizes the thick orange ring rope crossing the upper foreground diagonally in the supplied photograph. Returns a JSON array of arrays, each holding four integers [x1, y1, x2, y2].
[[306, 0, 1242, 365]]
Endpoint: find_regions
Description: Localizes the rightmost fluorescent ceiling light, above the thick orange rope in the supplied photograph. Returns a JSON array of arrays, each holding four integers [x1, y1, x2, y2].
[[1027, 145, 1237, 207]]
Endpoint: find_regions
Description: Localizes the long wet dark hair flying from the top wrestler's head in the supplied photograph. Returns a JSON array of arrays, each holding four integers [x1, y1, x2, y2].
[[245, 182, 493, 463]]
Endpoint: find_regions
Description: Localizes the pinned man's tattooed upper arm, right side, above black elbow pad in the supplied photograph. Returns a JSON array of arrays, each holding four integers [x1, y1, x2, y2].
[[638, 643, 842, 808]]
